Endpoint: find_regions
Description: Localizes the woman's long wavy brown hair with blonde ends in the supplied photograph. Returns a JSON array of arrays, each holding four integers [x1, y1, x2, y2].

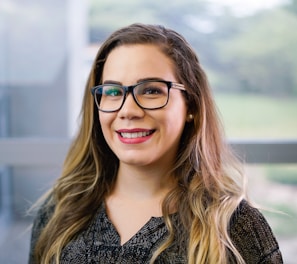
[[34, 24, 245, 264]]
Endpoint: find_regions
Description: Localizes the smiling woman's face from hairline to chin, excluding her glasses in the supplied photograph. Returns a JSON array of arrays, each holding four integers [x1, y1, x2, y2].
[[99, 44, 187, 167]]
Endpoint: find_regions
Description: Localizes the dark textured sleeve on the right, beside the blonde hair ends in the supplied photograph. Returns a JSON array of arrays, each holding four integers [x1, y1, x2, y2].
[[229, 200, 283, 264]]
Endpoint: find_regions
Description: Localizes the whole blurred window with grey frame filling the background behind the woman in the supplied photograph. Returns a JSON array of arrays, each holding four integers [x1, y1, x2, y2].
[[0, 0, 297, 263]]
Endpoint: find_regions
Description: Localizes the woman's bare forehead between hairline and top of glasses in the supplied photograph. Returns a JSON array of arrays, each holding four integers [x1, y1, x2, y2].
[[102, 44, 176, 83]]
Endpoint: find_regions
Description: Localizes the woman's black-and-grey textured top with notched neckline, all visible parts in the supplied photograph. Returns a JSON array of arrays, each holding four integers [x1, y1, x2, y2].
[[29, 201, 283, 264]]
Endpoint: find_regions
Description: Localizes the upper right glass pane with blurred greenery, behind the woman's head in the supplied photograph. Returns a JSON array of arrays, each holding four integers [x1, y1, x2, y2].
[[89, 0, 297, 139]]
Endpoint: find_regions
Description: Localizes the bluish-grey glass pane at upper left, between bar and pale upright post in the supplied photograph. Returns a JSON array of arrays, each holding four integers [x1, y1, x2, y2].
[[0, 0, 67, 137]]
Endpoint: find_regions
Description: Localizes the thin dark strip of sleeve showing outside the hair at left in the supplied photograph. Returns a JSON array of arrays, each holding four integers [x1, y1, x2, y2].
[[28, 197, 55, 264]]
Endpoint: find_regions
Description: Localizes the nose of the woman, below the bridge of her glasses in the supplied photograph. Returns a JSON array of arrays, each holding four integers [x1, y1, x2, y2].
[[118, 93, 144, 119]]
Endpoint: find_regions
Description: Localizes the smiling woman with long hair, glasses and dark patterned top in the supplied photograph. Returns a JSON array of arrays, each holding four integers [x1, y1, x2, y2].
[[30, 24, 282, 263]]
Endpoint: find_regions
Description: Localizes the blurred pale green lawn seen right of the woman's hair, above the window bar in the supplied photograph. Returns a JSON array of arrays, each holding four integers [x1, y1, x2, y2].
[[215, 93, 297, 138]]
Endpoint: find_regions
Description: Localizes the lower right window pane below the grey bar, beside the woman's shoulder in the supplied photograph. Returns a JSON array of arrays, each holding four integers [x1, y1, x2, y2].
[[246, 164, 297, 264]]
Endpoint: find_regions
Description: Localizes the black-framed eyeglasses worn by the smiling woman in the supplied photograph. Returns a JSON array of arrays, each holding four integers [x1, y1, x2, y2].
[[91, 80, 186, 113]]
